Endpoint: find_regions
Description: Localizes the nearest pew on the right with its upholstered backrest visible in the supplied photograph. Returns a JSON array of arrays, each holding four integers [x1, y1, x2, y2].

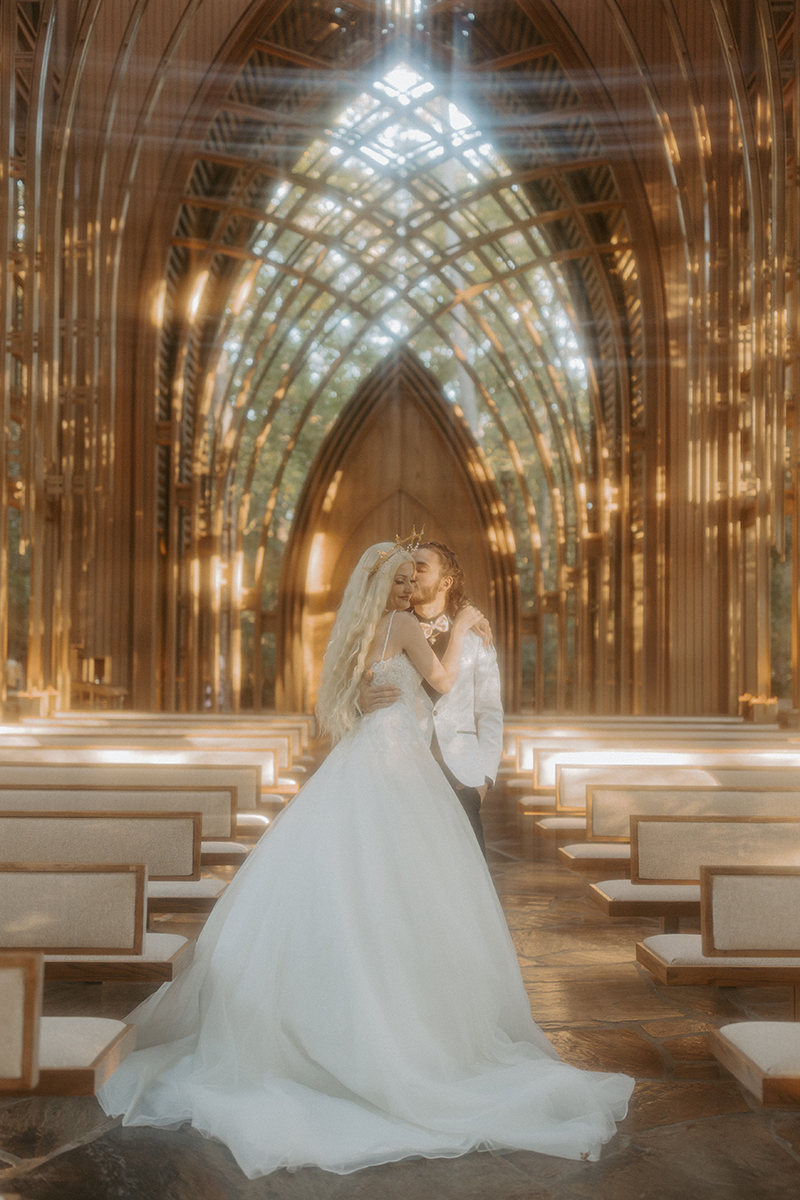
[[636, 864, 800, 1036]]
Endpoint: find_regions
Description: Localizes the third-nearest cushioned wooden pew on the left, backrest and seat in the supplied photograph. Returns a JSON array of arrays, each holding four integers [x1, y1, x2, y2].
[[0, 811, 225, 913]]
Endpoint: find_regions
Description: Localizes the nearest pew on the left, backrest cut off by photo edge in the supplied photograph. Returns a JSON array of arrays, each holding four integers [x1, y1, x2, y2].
[[0, 950, 136, 1096]]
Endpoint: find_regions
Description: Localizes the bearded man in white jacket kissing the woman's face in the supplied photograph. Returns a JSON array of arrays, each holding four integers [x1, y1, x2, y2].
[[360, 541, 503, 856]]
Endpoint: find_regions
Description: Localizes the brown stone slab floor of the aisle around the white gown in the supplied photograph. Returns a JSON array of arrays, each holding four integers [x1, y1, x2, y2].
[[0, 772, 800, 1200]]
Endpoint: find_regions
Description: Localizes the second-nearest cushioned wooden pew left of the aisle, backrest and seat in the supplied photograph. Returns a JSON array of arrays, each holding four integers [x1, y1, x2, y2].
[[0, 863, 194, 983]]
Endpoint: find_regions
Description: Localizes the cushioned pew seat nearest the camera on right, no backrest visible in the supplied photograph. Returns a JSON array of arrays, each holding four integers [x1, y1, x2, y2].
[[710, 1021, 800, 1109]]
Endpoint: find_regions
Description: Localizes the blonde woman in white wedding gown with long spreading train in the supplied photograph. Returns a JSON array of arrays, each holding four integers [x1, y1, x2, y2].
[[100, 542, 633, 1177]]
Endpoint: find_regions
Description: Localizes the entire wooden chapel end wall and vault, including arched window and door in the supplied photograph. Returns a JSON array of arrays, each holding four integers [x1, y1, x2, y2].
[[0, 0, 800, 720]]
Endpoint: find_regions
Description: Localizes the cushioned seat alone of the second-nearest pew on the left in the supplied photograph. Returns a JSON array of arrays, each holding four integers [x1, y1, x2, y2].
[[43, 932, 194, 983]]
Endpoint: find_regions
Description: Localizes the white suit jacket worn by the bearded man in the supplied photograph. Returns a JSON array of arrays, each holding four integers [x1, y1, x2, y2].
[[420, 629, 503, 787]]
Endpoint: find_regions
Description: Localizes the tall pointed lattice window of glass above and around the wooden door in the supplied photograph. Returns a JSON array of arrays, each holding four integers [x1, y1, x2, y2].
[[209, 55, 604, 611]]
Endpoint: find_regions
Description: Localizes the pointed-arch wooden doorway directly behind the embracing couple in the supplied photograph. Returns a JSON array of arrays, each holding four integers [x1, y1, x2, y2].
[[276, 349, 519, 710]]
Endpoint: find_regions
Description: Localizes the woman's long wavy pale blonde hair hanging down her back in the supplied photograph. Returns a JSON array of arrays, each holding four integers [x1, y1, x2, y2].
[[317, 541, 414, 742]]
